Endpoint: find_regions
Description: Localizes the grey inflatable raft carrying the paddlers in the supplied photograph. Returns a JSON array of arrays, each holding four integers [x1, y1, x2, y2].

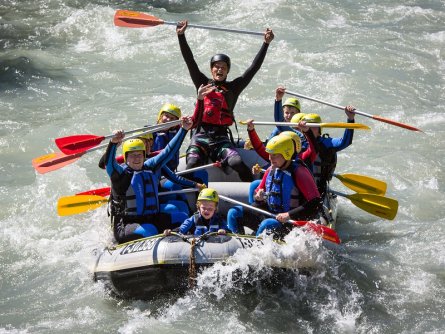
[[94, 149, 337, 299]]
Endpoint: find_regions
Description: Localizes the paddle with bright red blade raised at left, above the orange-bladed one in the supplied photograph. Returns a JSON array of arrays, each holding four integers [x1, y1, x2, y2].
[[55, 120, 181, 154]]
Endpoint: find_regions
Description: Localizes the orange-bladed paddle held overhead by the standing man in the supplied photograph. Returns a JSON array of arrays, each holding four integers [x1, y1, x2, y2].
[[114, 10, 264, 36]]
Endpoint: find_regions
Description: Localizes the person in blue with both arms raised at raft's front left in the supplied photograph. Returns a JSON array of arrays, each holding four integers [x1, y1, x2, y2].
[[105, 117, 193, 243]]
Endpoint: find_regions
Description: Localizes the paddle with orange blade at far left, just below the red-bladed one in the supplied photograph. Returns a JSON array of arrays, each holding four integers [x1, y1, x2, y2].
[[32, 123, 175, 174]]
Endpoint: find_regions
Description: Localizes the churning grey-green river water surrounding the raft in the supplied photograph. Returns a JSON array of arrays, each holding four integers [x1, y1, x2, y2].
[[0, 0, 445, 333]]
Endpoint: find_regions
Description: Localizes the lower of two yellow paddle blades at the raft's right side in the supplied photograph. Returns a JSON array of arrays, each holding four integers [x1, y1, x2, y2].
[[330, 190, 399, 220]]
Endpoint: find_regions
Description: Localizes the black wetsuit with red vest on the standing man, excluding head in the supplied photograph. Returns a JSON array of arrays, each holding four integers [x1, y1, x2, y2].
[[178, 34, 269, 182]]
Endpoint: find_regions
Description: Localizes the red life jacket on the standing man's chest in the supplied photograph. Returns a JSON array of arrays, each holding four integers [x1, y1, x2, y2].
[[202, 91, 233, 126]]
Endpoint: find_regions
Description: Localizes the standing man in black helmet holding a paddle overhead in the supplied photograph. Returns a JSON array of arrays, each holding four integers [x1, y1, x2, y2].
[[176, 21, 274, 182]]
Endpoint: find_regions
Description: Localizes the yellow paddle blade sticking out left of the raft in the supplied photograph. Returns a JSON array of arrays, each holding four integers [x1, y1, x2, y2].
[[57, 195, 108, 216]]
